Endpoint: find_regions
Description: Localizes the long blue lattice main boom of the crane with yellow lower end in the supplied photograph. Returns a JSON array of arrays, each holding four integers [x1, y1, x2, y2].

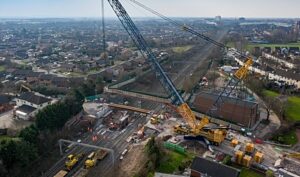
[[108, 0, 198, 131]]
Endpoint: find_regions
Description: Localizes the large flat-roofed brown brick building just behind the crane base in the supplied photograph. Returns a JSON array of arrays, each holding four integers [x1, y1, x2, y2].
[[193, 92, 259, 128]]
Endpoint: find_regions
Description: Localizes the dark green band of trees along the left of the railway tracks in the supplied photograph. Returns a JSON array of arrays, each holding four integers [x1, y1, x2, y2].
[[0, 89, 84, 177]]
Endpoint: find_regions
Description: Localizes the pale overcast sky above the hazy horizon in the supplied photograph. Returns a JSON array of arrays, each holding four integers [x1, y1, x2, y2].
[[0, 0, 300, 18]]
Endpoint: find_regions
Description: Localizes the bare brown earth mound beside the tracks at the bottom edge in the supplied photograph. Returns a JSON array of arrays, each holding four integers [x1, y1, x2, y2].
[[116, 145, 147, 177]]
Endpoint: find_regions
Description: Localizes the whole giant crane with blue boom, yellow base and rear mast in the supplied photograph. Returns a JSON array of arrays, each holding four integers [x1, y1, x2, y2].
[[108, 0, 253, 144]]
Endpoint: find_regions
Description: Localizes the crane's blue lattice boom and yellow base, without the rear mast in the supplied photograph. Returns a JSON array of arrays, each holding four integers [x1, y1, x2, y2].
[[108, 0, 226, 144]]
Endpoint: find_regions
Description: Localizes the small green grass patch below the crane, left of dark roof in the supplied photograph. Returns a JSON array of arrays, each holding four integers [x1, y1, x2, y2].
[[157, 151, 192, 173]]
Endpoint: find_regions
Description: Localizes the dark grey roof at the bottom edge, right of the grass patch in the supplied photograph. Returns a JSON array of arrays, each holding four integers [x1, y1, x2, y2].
[[191, 157, 240, 177]]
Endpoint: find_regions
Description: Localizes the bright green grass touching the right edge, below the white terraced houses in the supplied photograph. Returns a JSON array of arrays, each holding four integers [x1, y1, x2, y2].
[[285, 96, 300, 121]]
